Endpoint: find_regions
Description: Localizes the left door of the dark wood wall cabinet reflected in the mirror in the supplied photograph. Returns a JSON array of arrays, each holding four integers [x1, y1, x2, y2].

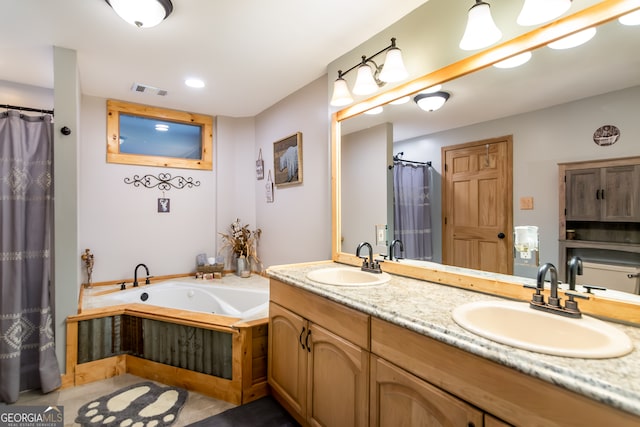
[[565, 168, 601, 221]]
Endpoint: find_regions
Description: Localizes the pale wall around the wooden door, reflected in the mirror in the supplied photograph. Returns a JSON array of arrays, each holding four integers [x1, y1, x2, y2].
[[394, 86, 640, 276]]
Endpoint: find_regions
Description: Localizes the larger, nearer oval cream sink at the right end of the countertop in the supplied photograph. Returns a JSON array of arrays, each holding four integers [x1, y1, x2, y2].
[[452, 301, 633, 359]]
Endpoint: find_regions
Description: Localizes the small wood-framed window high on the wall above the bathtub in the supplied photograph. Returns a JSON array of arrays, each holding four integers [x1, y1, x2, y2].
[[107, 99, 213, 170]]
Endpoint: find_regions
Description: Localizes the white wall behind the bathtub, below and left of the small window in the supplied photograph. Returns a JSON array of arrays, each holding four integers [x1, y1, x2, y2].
[[78, 96, 216, 282]]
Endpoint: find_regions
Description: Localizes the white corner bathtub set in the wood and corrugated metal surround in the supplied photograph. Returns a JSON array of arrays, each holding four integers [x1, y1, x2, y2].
[[94, 279, 269, 319]]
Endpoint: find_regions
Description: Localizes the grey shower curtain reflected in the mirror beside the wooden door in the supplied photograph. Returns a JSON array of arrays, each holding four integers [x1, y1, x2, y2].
[[393, 161, 433, 261]]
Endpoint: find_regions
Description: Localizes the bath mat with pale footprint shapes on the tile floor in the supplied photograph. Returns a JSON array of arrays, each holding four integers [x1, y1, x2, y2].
[[76, 382, 188, 427]]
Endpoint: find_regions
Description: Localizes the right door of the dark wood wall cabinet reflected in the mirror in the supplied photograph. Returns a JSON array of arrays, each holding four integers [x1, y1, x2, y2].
[[601, 165, 640, 221]]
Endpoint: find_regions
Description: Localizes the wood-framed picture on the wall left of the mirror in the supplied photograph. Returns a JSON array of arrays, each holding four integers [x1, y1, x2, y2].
[[273, 132, 302, 187]]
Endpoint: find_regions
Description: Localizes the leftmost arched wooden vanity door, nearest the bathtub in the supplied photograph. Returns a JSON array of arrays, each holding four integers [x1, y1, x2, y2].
[[268, 303, 308, 419]]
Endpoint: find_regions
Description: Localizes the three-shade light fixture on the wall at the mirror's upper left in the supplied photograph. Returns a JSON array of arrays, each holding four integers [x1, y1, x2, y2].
[[331, 37, 409, 107]]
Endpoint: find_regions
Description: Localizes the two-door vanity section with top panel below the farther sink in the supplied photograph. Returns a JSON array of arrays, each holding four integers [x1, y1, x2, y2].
[[268, 280, 369, 427]]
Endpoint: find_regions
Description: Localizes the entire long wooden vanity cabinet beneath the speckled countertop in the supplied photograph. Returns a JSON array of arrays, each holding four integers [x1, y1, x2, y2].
[[268, 279, 640, 427]]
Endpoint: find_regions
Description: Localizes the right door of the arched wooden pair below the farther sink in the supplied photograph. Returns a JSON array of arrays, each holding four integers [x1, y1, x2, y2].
[[308, 324, 369, 427]]
